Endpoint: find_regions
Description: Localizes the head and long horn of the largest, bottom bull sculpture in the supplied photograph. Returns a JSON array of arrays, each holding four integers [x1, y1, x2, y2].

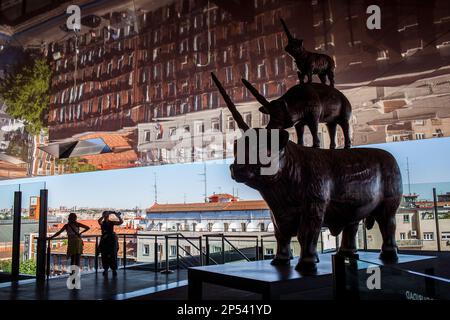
[[211, 73, 289, 189]]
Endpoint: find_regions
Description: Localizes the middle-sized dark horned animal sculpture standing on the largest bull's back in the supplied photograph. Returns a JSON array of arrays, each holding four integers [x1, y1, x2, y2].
[[242, 79, 352, 149]]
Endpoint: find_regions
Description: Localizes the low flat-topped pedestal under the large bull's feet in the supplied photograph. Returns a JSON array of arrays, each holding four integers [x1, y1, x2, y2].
[[188, 252, 435, 300]]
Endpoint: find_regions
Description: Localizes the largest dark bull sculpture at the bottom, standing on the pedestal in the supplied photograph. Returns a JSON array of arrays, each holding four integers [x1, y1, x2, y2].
[[212, 75, 402, 272]]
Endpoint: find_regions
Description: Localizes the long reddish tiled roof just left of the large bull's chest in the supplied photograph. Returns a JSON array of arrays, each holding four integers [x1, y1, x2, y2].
[[147, 200, 269, 213]]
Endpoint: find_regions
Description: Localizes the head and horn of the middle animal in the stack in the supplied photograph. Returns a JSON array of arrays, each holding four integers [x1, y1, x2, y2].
[[242, 79, 294, 129]]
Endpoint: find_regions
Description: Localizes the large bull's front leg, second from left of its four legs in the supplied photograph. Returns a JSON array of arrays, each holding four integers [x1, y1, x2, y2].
[[295, 203, 324, 272]]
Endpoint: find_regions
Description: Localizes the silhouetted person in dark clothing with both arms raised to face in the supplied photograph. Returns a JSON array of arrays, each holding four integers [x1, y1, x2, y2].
[[98, 211, 123, 277]]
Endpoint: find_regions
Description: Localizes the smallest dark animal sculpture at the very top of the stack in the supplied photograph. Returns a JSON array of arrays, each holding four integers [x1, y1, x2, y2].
[[280, 18, 336, 87]]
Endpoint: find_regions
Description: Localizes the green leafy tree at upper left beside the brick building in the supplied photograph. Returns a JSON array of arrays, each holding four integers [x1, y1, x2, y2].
[[0, 58, 51, 134]]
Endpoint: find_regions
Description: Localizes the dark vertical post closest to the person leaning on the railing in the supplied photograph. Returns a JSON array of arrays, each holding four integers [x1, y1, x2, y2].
[[36, 189, 48, 282]]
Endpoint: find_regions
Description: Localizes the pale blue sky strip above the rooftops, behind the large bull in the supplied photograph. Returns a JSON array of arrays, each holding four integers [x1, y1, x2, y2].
[[0, 138, 450, 208]]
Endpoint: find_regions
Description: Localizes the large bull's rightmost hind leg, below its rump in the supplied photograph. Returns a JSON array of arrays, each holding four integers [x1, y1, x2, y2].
[[375, 198, 400, 260]]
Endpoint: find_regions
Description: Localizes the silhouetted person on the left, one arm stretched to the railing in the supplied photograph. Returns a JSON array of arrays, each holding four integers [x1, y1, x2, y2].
[[47, 212, 90, 267]]
